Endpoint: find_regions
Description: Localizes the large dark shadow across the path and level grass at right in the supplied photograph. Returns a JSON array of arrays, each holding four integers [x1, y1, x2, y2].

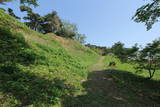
[[64, 69, 160, 107]]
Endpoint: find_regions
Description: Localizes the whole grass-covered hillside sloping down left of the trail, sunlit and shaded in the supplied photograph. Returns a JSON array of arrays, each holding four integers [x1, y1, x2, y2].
[[0, 10, 99, 107]]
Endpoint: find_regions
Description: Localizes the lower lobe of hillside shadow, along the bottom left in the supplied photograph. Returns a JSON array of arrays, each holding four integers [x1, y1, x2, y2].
[[0, 71, 74, 107]]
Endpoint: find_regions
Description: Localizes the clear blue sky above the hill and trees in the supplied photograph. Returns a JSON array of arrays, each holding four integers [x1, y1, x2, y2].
[[0, 0, 160, 47]]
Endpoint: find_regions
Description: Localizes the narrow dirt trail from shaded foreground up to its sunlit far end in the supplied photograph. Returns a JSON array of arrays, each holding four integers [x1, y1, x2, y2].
[[83, 56, 131, 107]]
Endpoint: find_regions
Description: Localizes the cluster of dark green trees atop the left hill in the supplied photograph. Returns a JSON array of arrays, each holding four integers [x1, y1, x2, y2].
[[20, 8, 61, 34]]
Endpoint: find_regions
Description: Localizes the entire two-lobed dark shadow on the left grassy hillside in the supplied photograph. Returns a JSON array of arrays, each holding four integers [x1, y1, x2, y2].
[[0, 26, 74, 107]]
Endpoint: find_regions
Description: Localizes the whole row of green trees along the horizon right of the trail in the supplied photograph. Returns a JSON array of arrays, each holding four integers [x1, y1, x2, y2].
[[86, 39, 160, 79]]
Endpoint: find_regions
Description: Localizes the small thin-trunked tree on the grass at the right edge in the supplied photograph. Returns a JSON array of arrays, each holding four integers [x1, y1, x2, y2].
[[136, 40, 160, 79]]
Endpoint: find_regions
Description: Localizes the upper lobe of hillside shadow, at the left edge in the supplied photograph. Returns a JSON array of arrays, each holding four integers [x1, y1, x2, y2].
[[0, 26, 47, 73]]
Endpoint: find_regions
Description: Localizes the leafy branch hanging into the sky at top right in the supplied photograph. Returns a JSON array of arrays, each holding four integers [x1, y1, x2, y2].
[[133, 0, 160, 30]]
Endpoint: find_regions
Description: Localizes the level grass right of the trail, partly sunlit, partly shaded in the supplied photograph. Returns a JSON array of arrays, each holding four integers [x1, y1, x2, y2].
[[104, 56, 160, 107]]
